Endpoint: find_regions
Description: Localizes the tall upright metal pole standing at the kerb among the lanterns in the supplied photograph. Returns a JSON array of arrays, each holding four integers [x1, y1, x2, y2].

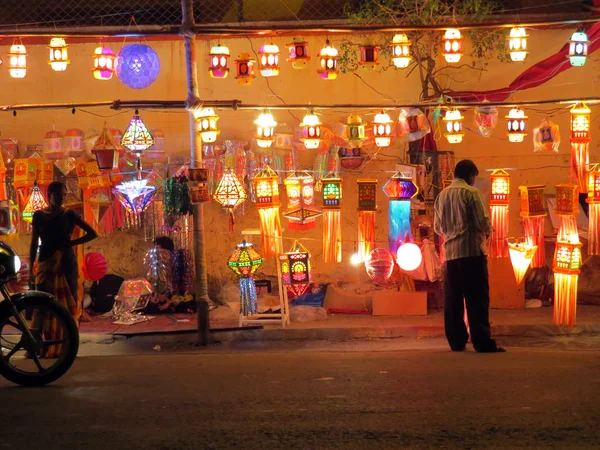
[[181, 0, 210, 345]]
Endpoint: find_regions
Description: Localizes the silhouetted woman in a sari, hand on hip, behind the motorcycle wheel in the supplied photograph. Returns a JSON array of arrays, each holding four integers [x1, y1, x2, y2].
[[29, 181, 98, 358]]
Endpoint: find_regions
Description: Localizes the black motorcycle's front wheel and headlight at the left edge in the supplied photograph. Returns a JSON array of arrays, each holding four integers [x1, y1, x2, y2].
[[0, 241, 79, 386]]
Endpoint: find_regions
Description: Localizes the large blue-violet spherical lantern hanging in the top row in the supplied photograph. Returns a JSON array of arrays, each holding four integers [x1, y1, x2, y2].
[[115, 44, 160, 89]]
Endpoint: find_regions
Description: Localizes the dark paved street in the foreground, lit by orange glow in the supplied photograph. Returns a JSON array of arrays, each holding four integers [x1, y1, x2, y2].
[[0, 343, 600, 450]]
